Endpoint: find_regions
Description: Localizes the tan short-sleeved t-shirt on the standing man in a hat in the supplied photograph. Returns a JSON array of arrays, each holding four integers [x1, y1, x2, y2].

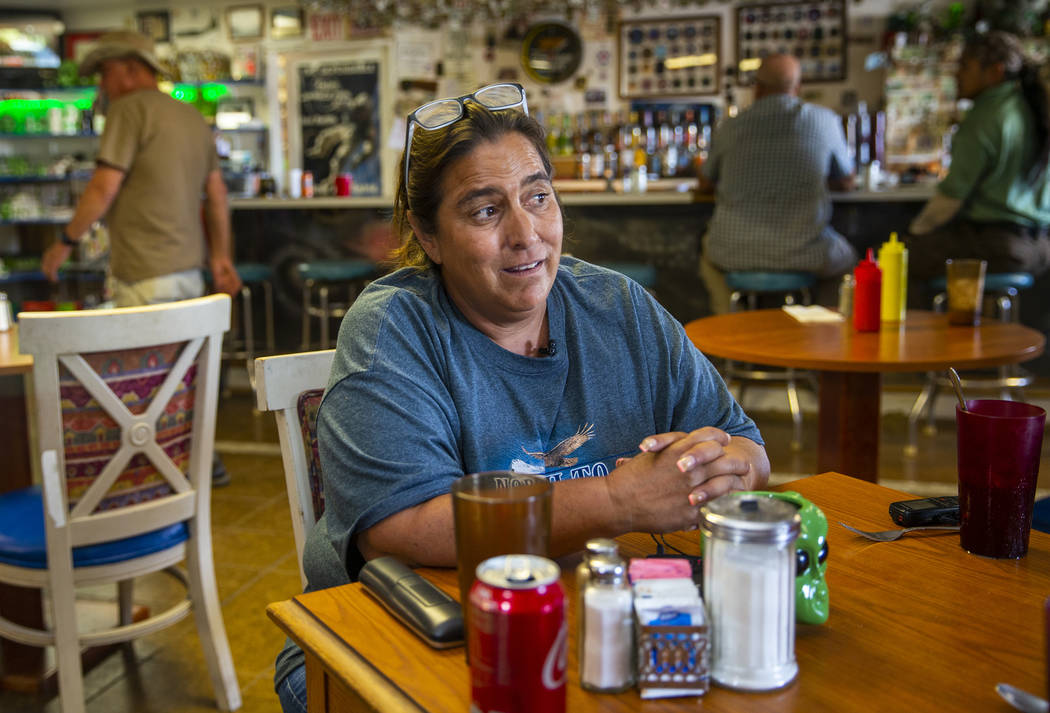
[[97, 89, 218, 282]]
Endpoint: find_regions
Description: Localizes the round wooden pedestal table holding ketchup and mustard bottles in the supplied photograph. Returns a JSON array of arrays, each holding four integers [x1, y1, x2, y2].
[[686, 310, 1046, 482]]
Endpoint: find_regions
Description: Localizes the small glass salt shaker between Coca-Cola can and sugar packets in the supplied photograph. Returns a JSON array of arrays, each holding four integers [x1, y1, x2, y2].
[[576, 538, 635, 693]]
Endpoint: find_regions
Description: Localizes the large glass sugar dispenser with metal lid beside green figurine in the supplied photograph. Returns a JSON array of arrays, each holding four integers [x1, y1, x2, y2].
[[700, 492, 801, 691]]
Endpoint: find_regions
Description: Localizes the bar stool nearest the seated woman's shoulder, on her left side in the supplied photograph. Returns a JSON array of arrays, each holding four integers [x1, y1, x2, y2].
[[295, 260, 376, 352]]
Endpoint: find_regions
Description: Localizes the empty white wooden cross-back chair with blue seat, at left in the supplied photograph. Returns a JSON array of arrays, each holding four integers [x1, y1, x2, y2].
[[0, 295, 240, 713]]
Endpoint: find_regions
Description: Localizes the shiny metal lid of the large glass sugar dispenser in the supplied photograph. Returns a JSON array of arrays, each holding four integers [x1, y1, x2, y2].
[[700, 492, 802, 545]]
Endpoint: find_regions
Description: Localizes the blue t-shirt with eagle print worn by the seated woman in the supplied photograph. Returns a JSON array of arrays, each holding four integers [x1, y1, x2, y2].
[[275, 257, 762, 683]]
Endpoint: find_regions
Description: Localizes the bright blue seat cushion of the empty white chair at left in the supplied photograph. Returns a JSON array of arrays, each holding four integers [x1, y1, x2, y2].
[[0, 486, 189, 569]]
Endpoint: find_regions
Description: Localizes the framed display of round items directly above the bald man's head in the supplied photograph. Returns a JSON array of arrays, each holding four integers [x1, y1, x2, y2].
[[734, 0, 846, 86]]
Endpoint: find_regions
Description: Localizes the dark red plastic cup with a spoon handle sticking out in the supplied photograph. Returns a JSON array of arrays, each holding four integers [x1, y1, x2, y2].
[[956, 399, 1047, 560]]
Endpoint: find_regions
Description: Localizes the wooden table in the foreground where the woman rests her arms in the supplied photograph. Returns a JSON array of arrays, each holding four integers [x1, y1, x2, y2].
[[267, 473, 1050, 713]]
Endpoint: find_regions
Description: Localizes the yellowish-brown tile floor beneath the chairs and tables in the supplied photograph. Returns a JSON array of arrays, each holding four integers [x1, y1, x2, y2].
[[0, 379, 1050, 713]]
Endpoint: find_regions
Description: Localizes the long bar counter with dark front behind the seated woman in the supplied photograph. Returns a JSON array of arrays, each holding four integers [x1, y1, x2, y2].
[[230, 179, 933, 331]]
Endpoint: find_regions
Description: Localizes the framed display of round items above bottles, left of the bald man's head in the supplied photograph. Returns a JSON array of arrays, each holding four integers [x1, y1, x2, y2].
[[618, 15, 721, 99]]
